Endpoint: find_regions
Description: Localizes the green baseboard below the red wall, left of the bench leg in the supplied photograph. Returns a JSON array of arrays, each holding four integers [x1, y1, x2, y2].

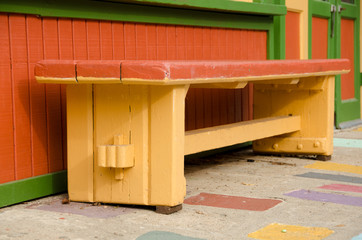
[[0, 171, 67, 208]]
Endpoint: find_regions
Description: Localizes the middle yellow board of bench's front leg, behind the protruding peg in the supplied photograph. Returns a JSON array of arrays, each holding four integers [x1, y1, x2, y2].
[[94, 84, 149, 205]]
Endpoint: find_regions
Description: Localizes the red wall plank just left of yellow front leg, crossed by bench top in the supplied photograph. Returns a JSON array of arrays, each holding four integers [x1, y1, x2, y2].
[[43, 18, 63, 172]]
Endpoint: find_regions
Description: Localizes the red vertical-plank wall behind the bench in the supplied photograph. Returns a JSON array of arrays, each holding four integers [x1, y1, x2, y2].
[[0, 14, 267, 184]]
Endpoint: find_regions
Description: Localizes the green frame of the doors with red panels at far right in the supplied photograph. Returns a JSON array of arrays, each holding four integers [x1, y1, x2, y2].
[[308, 0, 361, 128]]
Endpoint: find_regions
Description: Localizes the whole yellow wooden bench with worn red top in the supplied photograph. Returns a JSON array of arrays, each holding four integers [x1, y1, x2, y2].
[[35, 59, 350, 213]]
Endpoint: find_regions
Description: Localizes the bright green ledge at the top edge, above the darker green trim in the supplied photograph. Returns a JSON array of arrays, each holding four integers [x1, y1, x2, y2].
[[113, 0, 287, 15]]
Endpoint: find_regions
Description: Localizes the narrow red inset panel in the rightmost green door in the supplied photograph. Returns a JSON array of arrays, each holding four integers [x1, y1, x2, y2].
[[341, 18, 355, 100]]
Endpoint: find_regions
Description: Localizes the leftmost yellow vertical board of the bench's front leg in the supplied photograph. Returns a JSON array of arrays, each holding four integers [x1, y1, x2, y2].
[[67, 85, 93, 202]]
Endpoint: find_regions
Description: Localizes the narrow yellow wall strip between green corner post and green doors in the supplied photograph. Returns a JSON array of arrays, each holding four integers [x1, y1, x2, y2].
[[285, 0, 308, 59]]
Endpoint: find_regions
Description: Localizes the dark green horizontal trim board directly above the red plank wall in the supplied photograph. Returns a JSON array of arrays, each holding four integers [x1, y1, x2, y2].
[[0, 0, 273, 30]]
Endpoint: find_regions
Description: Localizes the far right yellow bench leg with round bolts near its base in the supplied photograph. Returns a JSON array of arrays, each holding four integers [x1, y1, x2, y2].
[[253, 76, 334, 155]]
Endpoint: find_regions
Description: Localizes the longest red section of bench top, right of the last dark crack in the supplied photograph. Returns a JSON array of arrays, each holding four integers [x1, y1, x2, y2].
[[121, 59, 350, 81]]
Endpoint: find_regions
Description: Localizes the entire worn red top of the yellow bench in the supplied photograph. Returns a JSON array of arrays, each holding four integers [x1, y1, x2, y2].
[[35, 59, 350, 83]]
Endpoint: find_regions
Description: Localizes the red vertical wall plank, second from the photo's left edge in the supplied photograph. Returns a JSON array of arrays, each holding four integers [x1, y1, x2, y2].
[[9, 15, 32, 179]]
